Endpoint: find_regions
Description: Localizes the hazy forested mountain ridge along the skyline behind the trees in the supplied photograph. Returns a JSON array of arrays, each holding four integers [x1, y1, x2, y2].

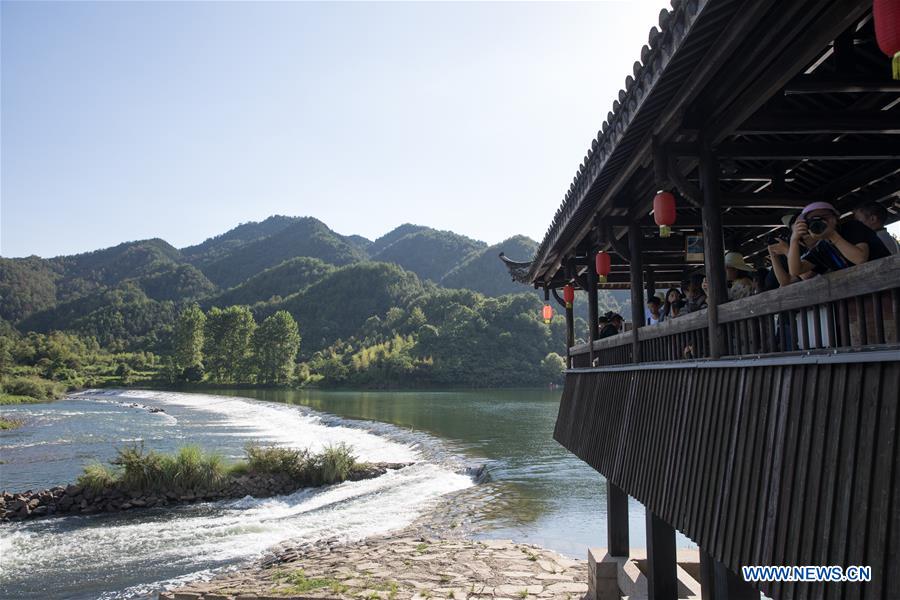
[[0, 215, 537, 339]]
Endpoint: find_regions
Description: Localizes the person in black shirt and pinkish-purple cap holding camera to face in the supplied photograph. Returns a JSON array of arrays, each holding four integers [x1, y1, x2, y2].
[[788, 202, 888, 277]]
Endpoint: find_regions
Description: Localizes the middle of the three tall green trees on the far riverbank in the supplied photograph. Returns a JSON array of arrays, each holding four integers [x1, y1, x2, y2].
[[203, 306, 256, 383]]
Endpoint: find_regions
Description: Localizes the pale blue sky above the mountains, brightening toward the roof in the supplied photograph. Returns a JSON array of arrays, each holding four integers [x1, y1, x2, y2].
[[0, 0, 663, 256]]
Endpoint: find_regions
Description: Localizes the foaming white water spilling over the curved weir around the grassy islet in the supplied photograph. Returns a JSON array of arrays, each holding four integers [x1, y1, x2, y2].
[[0, 391, 472, 598]]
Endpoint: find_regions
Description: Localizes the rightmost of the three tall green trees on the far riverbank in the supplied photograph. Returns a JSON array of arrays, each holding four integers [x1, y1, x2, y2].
[[253, 310, 300, 385]]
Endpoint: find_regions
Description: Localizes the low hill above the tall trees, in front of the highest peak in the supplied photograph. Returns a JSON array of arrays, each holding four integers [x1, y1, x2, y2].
[[202, 256, 335, 307]]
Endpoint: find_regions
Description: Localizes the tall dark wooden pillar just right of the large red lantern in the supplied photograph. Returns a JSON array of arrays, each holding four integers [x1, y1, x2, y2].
[[700, 141, 728, 358]]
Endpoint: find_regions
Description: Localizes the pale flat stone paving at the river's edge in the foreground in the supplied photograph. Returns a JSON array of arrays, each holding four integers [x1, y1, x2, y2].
[[160, 534, 588, 600]]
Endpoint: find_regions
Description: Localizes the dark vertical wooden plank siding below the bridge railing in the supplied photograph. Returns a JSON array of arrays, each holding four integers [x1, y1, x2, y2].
[[554, 350, 900, 600]]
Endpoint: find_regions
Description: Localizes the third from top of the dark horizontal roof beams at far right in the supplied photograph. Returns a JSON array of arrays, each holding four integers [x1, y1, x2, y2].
[[712, 140, 900, 160]]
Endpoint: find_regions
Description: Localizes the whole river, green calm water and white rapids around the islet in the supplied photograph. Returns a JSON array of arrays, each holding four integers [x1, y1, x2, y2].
[[0, 390, 668, 599]]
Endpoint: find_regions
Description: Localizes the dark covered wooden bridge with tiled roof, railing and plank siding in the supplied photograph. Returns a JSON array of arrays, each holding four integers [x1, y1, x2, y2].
[[504, 0, 900, 600]]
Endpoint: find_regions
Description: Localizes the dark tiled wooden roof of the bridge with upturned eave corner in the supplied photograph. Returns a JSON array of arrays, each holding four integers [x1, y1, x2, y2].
[[504, 0, 900, 286]]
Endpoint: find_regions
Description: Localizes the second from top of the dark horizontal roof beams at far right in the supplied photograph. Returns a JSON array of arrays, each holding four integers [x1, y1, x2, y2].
[[735, 111, 900, 135]]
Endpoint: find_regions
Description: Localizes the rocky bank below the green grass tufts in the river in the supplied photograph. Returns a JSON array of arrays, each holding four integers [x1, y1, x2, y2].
[[0, 463, 412, 521]]
